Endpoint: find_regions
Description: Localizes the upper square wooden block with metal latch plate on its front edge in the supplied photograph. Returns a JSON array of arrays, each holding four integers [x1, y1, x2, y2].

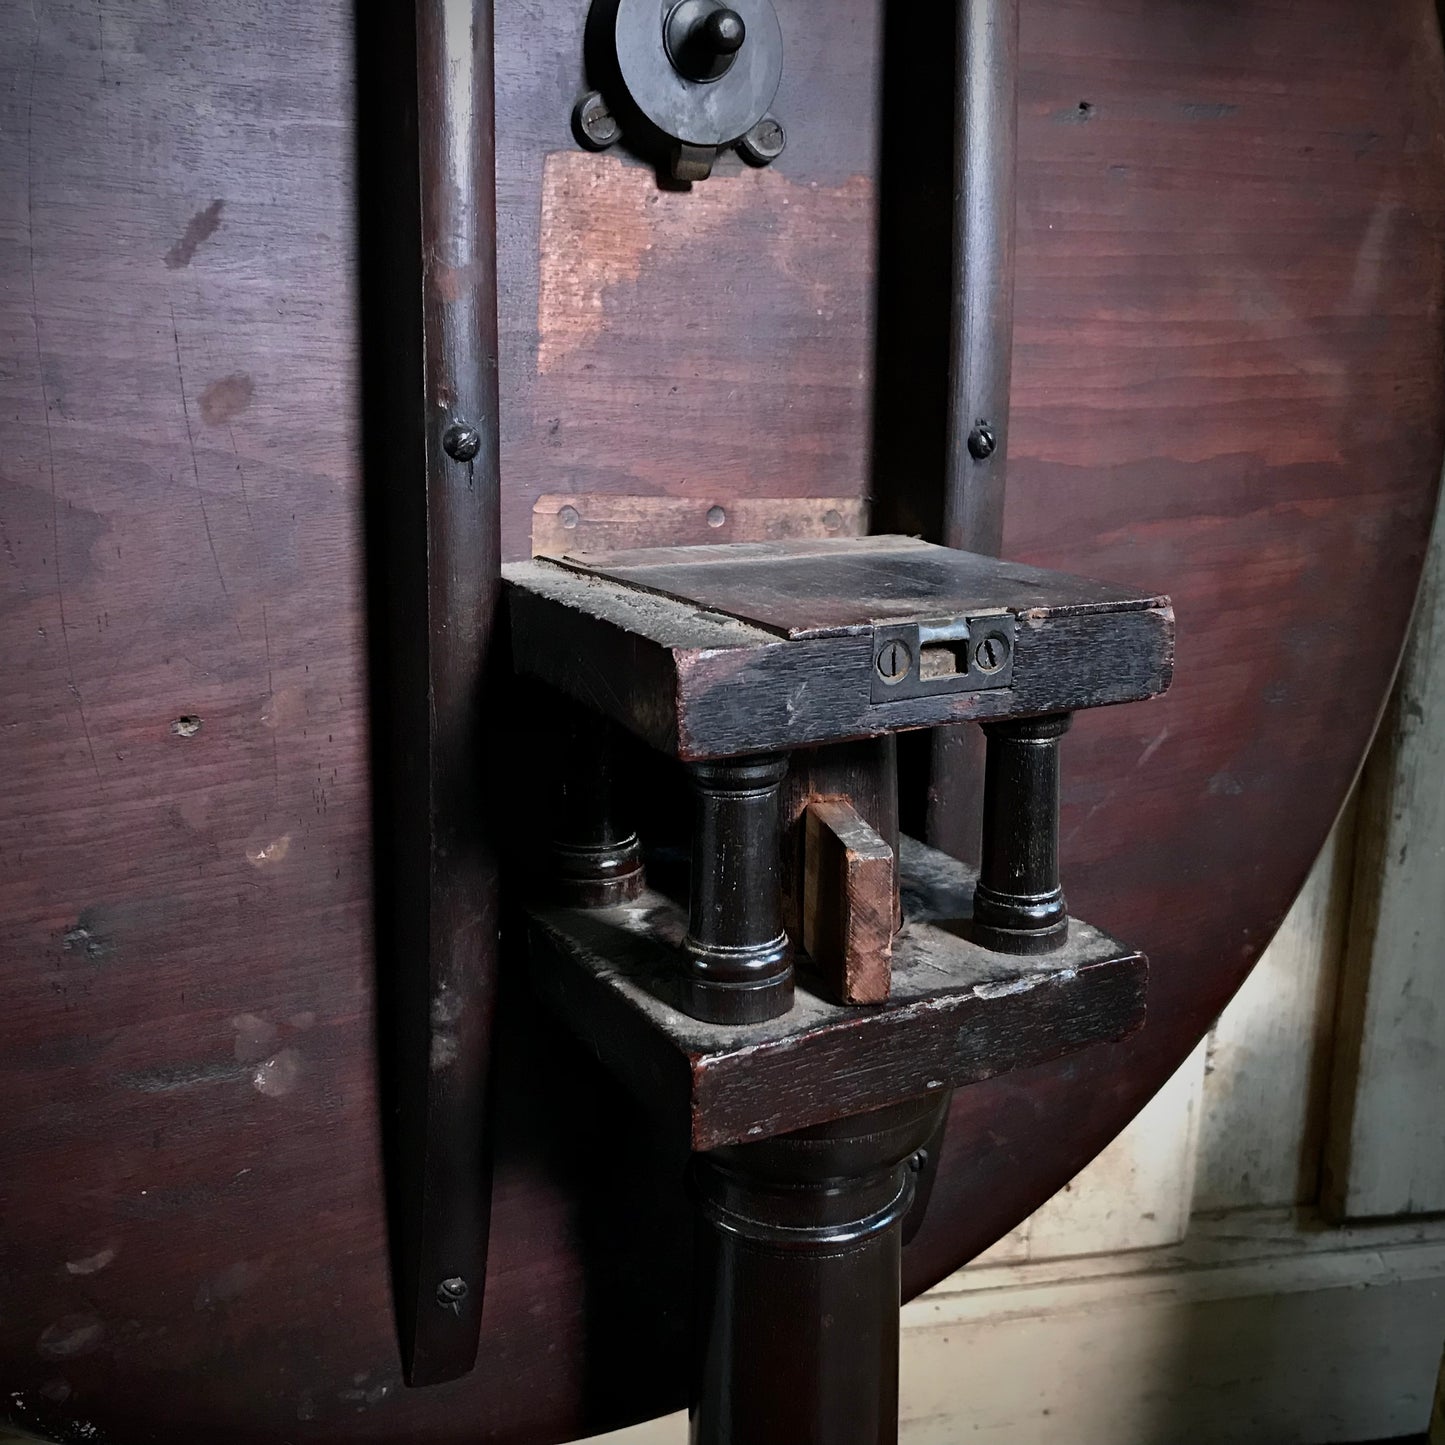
[[504, 536, 1173, 759]]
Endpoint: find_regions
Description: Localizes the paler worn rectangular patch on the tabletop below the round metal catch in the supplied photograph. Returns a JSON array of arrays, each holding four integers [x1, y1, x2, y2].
[[503, 140, 876, 558]]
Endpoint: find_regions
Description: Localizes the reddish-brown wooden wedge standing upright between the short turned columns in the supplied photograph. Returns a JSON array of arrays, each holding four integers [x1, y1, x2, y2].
[[802, 798, 894, 1003]]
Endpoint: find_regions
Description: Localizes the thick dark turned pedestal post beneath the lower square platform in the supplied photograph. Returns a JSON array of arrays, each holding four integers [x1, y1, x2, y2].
[[689, 1095, 945, 1445]]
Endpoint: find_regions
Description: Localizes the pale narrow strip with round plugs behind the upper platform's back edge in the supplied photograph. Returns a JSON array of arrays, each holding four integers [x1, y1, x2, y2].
[[532, 491, 868, 556]]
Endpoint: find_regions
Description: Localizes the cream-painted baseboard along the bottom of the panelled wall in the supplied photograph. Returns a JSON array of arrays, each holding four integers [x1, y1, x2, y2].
[[902, 1211, 1445, 1445]]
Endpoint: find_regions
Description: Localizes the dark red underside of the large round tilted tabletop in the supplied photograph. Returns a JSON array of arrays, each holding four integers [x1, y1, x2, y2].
[[0, 0, 1445, 1445]]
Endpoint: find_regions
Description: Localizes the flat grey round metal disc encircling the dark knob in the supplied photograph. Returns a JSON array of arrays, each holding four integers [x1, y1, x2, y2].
[[616, 0, 783, 146]]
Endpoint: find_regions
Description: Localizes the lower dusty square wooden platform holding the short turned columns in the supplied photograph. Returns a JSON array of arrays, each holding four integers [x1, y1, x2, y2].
[[530, 840, 1147, 1150]]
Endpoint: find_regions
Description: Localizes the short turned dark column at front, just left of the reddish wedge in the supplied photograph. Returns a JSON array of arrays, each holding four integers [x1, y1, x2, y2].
[[682, 754, 793, 1023]]
